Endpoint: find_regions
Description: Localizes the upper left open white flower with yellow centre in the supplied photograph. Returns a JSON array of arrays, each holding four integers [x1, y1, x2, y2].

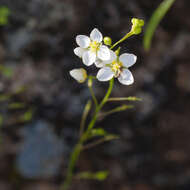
[[74, 28, 110, 66]]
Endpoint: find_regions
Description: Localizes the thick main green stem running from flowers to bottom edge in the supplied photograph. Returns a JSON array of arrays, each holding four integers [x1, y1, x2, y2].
[[60, 78, 114, 190]]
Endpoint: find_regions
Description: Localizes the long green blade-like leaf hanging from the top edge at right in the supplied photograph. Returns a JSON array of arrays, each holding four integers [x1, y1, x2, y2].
[[143, 0, 175, 51]]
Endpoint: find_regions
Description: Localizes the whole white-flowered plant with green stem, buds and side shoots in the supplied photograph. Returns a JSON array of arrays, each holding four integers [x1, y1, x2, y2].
[[60, 18, 144, 190]]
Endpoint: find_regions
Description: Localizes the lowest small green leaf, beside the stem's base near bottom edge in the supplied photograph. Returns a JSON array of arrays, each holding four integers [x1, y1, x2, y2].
[[77, 171, 108, 181]]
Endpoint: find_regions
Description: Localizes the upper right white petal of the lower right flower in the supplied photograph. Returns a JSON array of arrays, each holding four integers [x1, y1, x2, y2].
[[119, 53, 137, 68]]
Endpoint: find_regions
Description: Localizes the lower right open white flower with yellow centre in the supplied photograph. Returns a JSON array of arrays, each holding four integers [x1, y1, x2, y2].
[[96, 50, 137, 85]]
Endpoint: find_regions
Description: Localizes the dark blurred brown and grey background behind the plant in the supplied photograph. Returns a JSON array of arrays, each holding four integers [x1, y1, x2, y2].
[[0, 0, 190, 190]]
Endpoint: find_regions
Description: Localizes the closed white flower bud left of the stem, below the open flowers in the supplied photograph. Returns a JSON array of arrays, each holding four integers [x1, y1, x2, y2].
[[69, 68, 87, 83]]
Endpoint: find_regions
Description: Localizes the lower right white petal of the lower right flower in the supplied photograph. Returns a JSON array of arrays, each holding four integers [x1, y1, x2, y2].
[[118, 69, 134, 85]]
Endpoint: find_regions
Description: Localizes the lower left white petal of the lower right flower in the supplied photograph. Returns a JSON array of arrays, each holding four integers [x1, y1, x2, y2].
[[96, 67, 114, 81]]
